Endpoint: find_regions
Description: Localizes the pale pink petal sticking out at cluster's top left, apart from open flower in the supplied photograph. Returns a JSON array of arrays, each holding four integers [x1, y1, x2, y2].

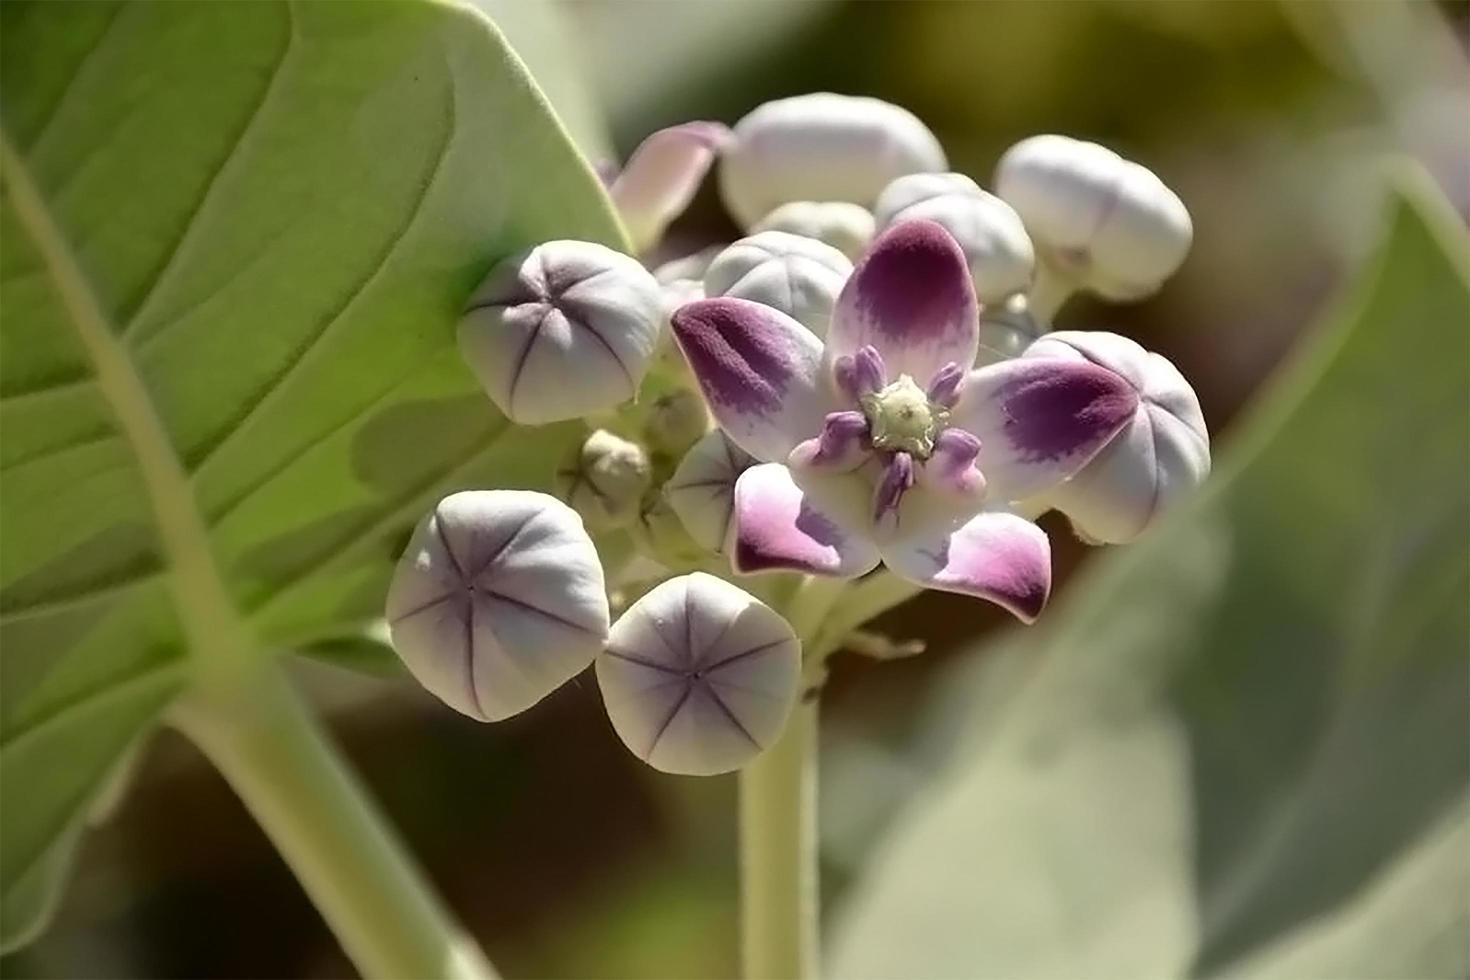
[[609, 122, 731, 253]]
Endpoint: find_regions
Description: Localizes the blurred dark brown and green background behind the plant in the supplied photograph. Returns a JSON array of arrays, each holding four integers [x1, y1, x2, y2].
[[0, 0, 1470, 979]]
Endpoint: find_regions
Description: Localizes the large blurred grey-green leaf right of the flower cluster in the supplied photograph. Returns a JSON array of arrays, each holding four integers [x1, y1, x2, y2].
[[832, 170, 1470, 980]]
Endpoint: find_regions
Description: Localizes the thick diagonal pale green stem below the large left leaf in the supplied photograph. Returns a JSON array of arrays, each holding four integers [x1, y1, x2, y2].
[[171, 664, 495, 980]]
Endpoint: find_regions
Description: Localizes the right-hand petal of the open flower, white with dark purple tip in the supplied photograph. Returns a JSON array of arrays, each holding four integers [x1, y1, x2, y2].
[[950, 357, 1138, 501]]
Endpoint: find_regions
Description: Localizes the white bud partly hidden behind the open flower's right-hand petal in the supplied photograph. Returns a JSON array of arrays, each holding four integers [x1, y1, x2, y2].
[[1025, 331, 1210, 544]]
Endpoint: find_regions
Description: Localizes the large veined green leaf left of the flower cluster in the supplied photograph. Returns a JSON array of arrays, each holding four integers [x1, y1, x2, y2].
[[0, 3, 622, 952]]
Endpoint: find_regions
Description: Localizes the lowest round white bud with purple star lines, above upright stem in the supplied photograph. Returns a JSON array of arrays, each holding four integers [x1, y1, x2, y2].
[[597, 572, 801, 776]]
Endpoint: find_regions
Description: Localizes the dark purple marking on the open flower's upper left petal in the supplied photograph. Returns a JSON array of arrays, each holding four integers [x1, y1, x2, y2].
[[672, 297, 794, 414]]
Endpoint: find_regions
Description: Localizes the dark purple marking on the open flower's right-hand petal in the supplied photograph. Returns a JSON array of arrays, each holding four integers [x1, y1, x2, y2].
[[998, 359, 1138, 461]]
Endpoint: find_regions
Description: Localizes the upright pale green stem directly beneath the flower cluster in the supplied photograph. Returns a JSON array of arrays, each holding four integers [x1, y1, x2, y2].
[[739, 577, 847, 980]]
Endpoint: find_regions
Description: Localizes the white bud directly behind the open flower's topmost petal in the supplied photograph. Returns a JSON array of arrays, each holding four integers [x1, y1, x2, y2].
[[875, 173, 1036, 304]]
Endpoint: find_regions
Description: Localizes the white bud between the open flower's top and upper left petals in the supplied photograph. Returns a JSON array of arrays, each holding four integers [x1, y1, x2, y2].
[[704, 231, 853, 336]]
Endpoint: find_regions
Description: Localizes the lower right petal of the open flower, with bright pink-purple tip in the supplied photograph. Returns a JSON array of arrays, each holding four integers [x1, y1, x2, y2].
[[883, 511, 1051, 623]]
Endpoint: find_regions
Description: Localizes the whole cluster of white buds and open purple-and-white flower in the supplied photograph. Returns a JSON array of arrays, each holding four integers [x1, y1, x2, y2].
[[388, 94, 1210, 774]]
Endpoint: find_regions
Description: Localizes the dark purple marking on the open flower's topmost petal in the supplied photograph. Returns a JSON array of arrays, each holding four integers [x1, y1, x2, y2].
[[848, 220, 979, 342]]
